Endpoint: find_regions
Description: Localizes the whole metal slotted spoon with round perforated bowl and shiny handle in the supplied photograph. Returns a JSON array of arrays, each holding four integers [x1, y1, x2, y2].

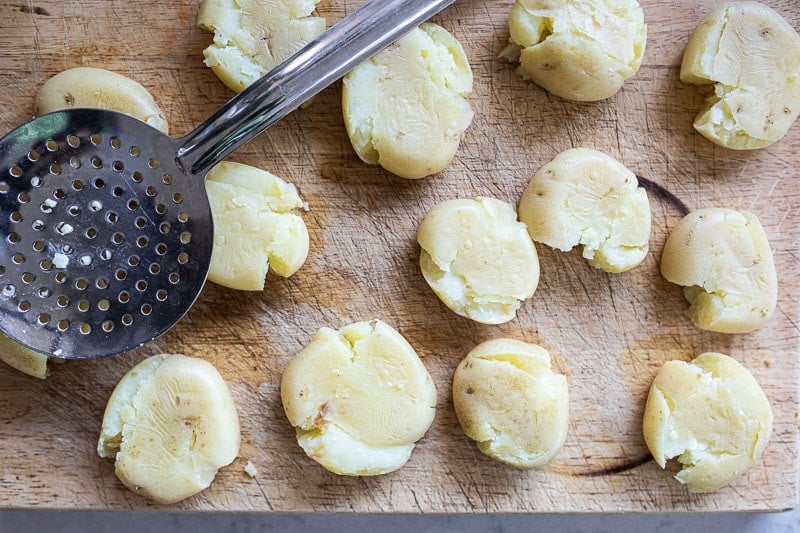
[[0, 0, 454, 359]]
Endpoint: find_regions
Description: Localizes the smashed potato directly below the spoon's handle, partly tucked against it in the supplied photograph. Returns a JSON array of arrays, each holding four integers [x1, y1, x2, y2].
[[342, 23, 473, 179]]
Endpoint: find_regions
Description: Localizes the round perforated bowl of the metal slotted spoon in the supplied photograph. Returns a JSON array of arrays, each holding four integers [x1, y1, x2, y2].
[[0, 111, 212, 358]]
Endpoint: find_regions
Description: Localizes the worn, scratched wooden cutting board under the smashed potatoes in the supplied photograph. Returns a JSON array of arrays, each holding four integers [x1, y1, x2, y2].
[[0, 0, 800, 513]]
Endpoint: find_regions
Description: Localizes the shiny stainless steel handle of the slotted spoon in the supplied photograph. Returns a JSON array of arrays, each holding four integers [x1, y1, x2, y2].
[[177, 0, 454, 174]]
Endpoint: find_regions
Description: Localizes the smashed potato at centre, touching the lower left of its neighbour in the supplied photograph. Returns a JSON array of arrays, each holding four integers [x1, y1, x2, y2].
[[417, 197, 539, 324]]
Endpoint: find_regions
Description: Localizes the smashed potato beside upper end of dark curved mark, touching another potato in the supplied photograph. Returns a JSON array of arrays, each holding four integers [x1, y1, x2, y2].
[[519, 148, 651, 273]]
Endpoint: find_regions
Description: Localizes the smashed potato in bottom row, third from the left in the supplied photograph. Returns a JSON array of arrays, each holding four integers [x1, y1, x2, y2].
[[453, 338, 569, 468]]
